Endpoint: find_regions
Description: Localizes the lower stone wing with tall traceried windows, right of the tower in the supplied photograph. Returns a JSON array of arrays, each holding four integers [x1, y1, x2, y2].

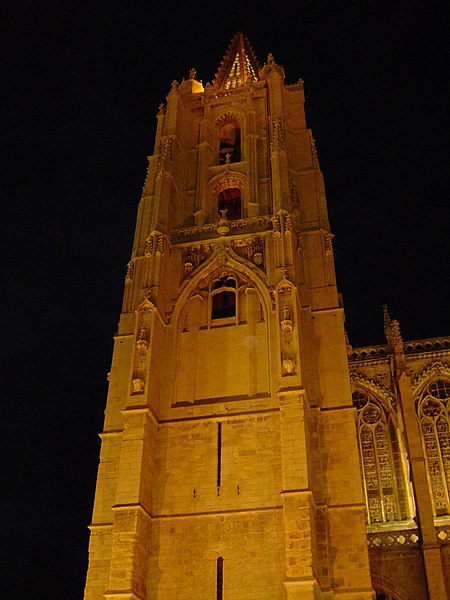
[[348, 326, 450, 600]]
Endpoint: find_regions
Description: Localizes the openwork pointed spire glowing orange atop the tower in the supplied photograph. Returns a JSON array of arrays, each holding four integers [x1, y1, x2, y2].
[[214, 31, 259, 90]]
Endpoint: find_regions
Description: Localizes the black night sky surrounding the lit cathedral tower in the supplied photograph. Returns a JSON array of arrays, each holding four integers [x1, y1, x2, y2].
[[0, 0, 450, 600]]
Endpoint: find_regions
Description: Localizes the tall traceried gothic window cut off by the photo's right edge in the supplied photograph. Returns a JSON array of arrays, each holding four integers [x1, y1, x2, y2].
[[417, 379, 450, 516]]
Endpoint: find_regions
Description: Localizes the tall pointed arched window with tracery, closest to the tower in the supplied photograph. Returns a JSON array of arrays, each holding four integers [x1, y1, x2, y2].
[[353, 390, 410, 523]]
